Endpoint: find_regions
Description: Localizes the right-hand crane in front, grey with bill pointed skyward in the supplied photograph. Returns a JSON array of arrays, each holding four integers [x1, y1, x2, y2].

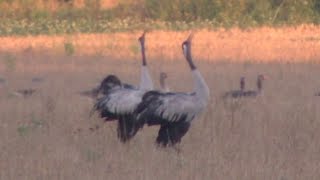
[[135, 34, 209, 147]]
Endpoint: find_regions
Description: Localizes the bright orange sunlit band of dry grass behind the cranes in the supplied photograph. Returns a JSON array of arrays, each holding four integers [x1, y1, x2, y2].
[[0, 25, 320, 62]]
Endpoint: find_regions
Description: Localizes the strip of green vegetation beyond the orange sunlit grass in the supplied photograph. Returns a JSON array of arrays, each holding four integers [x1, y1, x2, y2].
[[0, 0, 320, 35]]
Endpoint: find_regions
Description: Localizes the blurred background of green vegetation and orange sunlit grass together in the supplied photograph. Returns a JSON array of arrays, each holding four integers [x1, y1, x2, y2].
[[0, 0, 320, 63]]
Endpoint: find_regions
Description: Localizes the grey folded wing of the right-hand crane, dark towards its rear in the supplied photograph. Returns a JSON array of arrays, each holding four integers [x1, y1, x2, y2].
[[135, 91, 201, 125]]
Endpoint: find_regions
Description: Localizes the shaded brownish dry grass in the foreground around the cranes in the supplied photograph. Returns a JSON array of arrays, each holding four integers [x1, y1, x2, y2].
[[0, 51, 320, 180]]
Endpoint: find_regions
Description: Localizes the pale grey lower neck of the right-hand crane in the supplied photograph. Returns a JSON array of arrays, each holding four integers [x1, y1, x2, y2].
[[192, 69, 210, 105]]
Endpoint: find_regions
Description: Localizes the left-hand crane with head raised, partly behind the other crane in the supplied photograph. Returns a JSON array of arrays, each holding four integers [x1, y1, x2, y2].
[[93, 32, 153, 142]]
